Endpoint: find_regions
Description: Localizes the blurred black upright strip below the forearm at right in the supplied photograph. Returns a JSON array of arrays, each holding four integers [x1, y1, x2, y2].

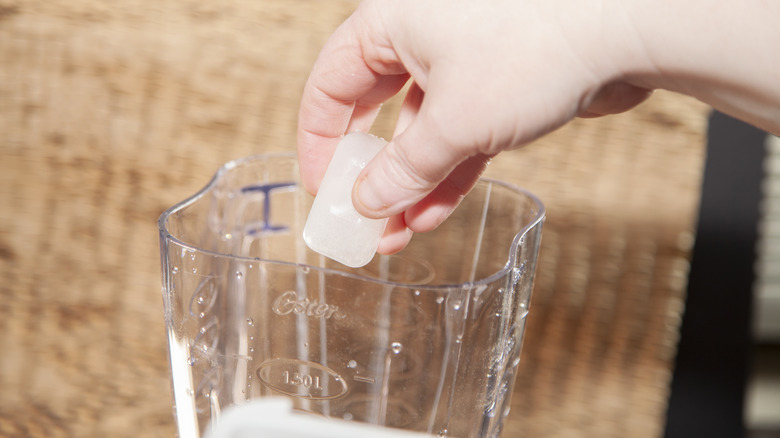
[[665, 112, 766, 438]]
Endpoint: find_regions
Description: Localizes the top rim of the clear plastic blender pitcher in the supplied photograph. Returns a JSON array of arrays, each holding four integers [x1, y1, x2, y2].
[[157, 152, 545, 290]]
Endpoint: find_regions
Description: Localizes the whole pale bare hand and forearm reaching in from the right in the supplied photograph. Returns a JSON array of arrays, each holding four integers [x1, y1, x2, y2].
[[298, 0, 780, 254]]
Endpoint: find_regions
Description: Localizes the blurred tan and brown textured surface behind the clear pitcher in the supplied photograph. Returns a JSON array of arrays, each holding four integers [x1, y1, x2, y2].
[[0, 0, 708, 437]]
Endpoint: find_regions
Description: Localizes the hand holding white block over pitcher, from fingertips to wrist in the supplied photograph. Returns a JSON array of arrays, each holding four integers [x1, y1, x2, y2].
[[298, 0, 648, 253]]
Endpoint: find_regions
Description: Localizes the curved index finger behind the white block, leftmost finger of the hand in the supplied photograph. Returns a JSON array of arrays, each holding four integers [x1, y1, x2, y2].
[[297, 9, 409, 193]]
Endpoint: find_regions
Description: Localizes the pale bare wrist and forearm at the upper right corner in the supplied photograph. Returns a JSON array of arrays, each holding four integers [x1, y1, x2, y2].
[[617, 0, 780, 132]]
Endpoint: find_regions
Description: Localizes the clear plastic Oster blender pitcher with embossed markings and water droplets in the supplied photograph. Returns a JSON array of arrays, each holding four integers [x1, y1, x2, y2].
[[159, 154, 544, 438]]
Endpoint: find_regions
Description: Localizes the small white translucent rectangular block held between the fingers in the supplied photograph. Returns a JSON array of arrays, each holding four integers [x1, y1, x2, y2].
[[303, 132, 387, 268]]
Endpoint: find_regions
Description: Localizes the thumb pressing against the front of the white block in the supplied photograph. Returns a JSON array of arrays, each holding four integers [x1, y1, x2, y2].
[[352, 114, 467, 218]]
